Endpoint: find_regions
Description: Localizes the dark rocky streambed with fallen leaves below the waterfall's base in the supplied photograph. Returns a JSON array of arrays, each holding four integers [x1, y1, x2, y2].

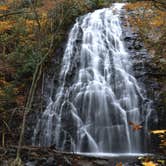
[[0, 146, 164, 166]]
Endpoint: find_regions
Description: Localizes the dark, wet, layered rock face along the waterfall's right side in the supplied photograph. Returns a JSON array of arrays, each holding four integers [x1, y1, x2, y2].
[[121, 10, 166, 154]]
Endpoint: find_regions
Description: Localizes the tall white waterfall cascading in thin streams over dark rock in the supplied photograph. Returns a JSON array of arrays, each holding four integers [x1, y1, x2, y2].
[[33, 4, 150, 153]]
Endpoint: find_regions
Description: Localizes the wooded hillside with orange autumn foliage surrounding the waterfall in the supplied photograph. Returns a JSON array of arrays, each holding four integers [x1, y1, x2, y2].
[[0, 0, 166, 166]]
